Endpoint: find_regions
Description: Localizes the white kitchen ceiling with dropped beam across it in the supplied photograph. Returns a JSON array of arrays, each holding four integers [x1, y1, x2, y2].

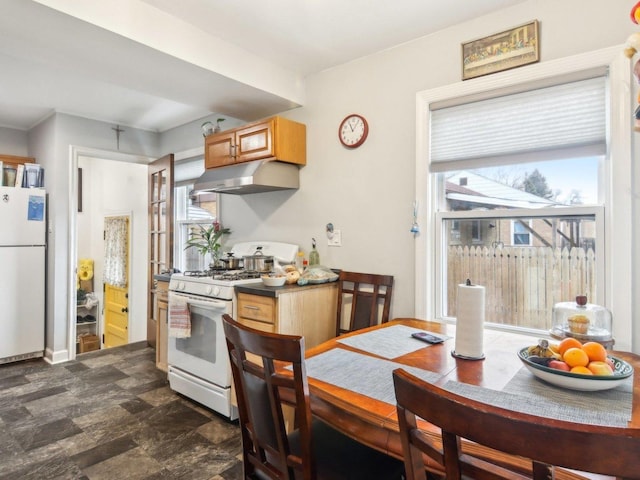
[[0, 0, 525, 132]]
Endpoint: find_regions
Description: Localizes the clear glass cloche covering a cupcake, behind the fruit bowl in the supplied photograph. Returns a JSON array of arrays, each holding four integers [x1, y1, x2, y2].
[[551, 295, 614, 348]]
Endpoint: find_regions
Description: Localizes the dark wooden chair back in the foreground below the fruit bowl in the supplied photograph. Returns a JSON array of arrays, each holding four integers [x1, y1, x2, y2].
[[393, 368, 640, 480]]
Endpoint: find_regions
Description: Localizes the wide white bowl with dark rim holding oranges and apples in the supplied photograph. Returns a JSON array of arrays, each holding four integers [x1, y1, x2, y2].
[[518, 347, 633, 391]]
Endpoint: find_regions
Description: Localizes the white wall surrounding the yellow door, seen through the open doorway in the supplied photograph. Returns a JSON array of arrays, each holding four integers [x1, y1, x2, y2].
[[77, 157, 149, 342]]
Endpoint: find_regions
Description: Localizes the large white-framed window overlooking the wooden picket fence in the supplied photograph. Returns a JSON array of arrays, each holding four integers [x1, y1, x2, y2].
[[416, 49, 632, 346]]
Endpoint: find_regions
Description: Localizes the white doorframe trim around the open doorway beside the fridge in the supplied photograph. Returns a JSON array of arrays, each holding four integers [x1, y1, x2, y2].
[[67, 145, 154, 360]]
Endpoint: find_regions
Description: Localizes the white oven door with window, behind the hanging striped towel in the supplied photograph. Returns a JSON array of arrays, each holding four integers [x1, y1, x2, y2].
[[167, 292, 232, 388]]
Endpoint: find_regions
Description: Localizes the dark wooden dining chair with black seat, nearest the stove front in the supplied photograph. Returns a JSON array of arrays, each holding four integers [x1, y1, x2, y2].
[[223, 315, 404, 480]]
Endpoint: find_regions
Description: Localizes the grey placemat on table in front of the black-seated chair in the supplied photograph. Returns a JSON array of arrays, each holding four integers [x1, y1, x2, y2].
[[306, 346, 441, 405]]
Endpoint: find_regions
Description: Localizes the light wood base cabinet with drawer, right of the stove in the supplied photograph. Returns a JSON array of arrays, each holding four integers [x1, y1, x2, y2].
[[236, 283, 338, 348]]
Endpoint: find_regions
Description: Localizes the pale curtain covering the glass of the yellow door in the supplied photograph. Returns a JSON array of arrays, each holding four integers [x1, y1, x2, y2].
[[104, 217, 129, 287]]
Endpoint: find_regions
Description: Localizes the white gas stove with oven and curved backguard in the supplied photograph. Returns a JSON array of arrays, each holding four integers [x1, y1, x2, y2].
[[167, 242, 298, 420]]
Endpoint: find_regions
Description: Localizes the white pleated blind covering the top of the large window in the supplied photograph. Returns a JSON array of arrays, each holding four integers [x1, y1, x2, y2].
[[430, 77, 606, 172]]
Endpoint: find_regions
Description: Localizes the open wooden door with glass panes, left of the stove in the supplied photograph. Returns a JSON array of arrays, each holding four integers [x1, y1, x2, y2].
[[147, 154, 173, 348]]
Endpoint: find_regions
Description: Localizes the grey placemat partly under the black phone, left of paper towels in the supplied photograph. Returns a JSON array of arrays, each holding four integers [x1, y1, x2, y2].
[[338, 325, 451, 358]]
